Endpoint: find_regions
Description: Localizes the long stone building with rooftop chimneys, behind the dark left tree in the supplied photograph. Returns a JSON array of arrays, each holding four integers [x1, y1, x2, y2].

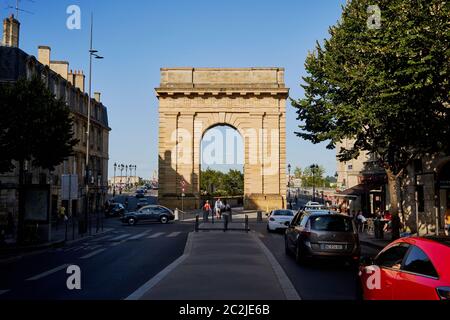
[[0, 17, 110, 240]]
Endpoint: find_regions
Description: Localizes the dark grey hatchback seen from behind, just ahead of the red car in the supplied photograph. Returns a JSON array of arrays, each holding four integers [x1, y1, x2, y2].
[[285, 210, 361, 267]]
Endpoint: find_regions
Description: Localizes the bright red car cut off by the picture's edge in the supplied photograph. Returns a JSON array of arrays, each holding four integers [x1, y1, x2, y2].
[[360, 237, 450, 300]]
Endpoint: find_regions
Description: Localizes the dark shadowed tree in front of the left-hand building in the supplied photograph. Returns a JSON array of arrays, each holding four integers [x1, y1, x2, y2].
[[0, 77, 78, 242]]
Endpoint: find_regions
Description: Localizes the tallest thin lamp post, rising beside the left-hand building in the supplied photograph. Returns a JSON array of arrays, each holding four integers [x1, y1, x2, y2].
[[85, 14, 103, 234]]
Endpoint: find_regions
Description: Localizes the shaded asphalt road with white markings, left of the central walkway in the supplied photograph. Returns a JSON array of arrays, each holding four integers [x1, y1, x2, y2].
[[0, 220, 193, 300]]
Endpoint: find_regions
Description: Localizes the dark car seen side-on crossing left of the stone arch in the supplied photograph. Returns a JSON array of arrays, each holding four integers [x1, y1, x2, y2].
[[122, 205, 175, 226]]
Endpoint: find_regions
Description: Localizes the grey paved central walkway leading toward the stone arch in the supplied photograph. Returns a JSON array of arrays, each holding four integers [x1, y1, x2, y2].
[[127, 231, 300, 300]]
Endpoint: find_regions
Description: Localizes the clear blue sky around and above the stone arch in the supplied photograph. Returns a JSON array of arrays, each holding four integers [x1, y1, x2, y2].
[[5, 0, 345, 178]]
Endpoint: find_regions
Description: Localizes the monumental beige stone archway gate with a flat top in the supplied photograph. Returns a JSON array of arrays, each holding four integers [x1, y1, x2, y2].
[[156, 68, 289, 210]]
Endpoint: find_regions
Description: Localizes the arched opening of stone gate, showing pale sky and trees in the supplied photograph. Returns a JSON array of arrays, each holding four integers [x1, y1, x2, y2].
[[199, 124, 245, 207]]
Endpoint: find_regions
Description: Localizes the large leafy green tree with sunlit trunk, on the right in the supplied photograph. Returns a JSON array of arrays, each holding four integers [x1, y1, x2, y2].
[[293, 0, 450, 239]]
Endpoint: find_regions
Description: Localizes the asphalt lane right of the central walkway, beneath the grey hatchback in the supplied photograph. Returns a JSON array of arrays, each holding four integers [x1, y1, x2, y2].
[[250, 223, 378, 300]]
